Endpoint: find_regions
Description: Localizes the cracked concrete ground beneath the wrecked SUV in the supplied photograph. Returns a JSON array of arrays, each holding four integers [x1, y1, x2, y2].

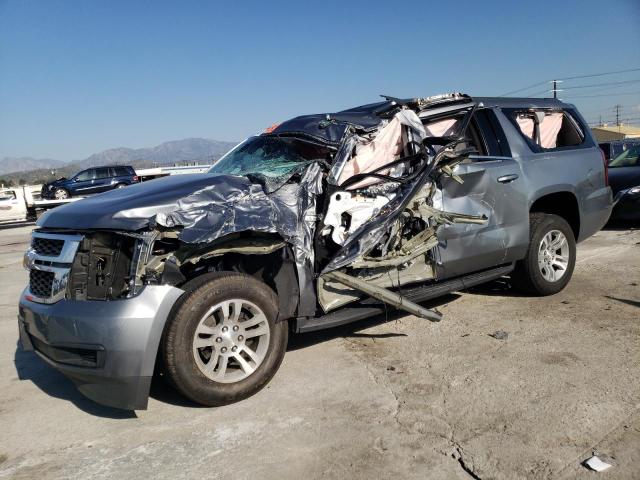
[[0, 223, 640, 479]]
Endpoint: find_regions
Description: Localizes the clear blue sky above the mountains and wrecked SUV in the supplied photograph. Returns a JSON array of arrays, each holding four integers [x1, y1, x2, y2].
[[0, 0, 640, 160]]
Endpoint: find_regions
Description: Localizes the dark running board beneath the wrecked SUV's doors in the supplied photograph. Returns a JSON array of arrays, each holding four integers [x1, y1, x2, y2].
[[295, 264, 514, 333]]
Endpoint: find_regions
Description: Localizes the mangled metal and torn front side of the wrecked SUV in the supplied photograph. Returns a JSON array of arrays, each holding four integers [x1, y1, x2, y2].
[[145, 94, 487, 320]]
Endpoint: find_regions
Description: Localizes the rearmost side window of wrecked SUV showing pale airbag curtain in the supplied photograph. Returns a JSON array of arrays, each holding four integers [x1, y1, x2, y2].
[[508, 109, 585, 151]]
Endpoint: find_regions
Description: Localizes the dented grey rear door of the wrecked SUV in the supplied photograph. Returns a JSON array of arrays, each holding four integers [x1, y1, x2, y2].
[[434, 109, 529, 278]]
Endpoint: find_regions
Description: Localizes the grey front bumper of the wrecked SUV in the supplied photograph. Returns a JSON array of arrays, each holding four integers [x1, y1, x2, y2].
[[18, 285, 183, 410]]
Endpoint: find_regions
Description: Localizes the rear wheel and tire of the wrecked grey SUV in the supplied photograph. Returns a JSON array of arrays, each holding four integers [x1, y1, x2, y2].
[[511, 213, 576, 296]]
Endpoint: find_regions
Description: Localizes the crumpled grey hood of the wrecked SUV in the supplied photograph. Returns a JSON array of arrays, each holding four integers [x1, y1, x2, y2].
[[38, 173, 260, 230]]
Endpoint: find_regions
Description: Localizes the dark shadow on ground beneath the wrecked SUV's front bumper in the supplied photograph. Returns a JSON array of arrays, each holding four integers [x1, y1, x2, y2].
[[14, 342, 136, 420]]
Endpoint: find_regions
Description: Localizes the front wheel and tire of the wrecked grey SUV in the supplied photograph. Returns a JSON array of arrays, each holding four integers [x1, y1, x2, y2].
[[160, 272, 288, 406]]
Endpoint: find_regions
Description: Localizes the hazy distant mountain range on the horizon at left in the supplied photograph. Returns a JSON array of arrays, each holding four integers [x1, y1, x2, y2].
[[0, 138, 236, 175]]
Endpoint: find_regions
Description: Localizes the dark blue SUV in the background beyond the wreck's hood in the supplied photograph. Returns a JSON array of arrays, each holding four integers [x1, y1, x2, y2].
[[41, 165, 140, 200]]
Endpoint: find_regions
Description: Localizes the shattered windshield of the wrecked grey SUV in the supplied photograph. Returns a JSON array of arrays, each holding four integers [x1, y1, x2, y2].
[[209, 136, 331, 191]]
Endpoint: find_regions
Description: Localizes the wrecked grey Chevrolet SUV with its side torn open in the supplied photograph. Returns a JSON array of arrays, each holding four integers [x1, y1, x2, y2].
[[19, 94, 611, 409]]
